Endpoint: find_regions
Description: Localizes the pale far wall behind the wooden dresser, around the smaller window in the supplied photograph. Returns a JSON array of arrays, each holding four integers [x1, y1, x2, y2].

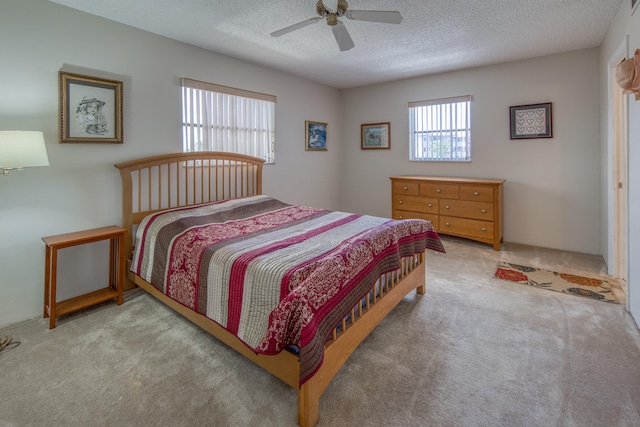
[[341, 49, 601, 254]]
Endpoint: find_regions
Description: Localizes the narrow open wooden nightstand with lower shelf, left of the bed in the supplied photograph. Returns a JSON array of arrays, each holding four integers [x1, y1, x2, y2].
[[42, 225, 127, 329]]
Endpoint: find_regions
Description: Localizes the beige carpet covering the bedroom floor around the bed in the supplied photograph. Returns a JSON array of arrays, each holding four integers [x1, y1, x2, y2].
[[0, 237, 640, 427]]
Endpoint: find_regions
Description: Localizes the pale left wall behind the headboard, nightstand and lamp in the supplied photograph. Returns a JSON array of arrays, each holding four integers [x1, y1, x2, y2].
[[0, 0, 342, 327]]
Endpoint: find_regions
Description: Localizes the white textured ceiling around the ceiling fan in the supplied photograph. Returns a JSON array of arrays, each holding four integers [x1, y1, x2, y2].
[[51, 0, 622, 89]]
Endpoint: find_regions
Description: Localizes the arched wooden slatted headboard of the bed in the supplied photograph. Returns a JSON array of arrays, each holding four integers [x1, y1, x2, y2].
[[115, 151, 264, 288]]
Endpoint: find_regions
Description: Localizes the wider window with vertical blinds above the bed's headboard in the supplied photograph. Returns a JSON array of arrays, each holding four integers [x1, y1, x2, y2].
[[182, 78, 276, 163]]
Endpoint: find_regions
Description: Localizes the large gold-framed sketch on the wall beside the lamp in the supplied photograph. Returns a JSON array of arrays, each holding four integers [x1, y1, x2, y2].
[[59, 71, 123, 144]]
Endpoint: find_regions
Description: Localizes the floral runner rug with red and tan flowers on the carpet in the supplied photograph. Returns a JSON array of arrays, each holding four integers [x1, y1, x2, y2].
[[495, 262, 619, 304]]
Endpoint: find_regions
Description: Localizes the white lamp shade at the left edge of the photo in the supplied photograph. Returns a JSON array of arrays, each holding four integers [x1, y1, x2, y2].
[[0, 130, 49, 169]]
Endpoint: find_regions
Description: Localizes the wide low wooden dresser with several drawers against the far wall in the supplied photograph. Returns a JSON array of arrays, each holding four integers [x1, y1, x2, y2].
[[390, 176, 505, 251]]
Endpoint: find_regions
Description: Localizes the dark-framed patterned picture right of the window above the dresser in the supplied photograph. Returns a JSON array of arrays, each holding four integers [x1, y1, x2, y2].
[[509, 102, 553, 139]]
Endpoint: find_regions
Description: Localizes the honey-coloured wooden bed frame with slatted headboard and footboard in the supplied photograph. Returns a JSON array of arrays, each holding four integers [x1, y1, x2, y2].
[[115, 152, 425, 427]]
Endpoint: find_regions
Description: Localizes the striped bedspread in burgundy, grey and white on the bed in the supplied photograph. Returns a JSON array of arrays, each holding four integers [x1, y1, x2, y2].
[[131, 196, 444, 383]]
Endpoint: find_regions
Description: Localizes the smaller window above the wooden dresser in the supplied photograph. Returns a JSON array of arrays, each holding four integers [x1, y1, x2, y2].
[[408, 95, 471, 162]]
